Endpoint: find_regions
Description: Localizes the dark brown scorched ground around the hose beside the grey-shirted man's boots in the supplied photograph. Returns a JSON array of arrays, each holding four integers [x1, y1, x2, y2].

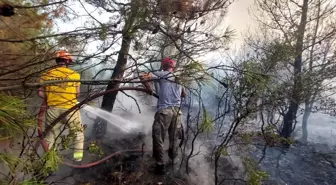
[[47, 132, 187, 185]]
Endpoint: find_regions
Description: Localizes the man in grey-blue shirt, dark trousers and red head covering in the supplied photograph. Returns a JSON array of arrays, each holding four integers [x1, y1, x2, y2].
[[140, 57, 186, 175]]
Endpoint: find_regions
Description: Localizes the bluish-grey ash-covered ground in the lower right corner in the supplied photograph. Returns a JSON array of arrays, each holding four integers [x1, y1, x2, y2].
[[252, 142, 336, 185]]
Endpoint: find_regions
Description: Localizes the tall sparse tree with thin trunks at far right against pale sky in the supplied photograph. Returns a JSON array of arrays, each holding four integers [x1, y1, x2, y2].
[[251, 0, 335, 140]]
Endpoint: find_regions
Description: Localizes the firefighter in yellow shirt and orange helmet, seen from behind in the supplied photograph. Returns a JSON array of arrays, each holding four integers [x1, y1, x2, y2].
[[38, 50, 84, 162]]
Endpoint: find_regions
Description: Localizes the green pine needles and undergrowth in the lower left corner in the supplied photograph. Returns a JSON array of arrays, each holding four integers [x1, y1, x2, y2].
[[0, 94, 61, 185]]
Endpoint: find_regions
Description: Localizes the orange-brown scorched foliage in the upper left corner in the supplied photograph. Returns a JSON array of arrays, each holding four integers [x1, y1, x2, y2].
[[0, 0, 57, 95]]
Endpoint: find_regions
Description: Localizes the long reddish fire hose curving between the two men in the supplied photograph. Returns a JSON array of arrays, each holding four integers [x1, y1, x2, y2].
[[35, 87, 182, 168]]
